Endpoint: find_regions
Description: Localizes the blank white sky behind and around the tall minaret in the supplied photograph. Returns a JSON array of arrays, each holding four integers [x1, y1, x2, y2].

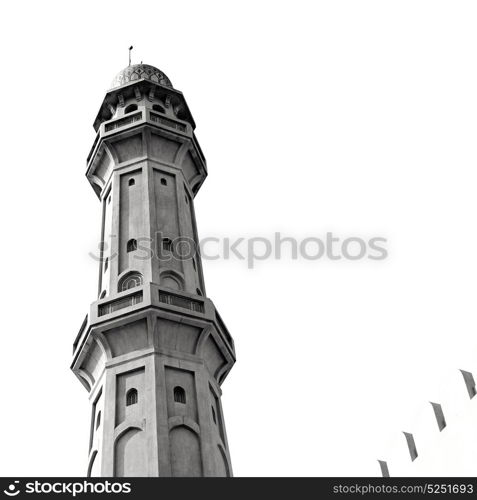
[[0, 0, 477, 476]]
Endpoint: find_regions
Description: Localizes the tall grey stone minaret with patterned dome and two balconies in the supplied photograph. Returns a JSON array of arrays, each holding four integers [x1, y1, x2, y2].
[[71, 64, 235, 477]]
